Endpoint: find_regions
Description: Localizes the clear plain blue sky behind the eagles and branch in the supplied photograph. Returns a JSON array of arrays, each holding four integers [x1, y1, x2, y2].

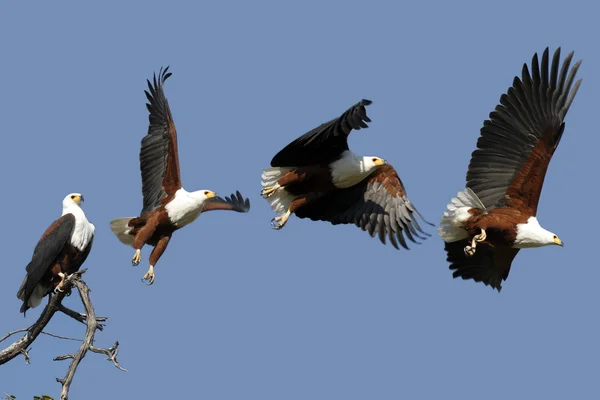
[[0, 1, 600, 400]]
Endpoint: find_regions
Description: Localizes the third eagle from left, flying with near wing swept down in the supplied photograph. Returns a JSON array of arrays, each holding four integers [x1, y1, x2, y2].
[[261, 100, 430, 249]]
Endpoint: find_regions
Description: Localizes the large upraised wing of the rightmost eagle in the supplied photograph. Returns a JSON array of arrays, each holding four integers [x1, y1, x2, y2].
[[467, 48, 581, 215]]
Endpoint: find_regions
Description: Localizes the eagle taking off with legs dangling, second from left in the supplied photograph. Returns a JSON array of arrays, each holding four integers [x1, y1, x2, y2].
[[110, 67, 250, 285]]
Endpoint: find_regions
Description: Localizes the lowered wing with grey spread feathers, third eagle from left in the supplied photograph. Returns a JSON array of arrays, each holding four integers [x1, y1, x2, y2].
[[295, 165, 431, 249]]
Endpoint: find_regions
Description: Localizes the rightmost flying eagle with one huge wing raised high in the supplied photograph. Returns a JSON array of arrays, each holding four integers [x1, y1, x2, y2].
[[439, 48, 581, 291]]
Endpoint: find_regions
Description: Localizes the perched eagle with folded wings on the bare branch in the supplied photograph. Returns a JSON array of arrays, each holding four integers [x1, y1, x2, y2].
[[17, 193, 95, 313]]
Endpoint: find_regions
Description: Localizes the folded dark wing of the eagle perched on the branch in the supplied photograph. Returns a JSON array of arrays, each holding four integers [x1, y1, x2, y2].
[[17, 214, 75, 312]]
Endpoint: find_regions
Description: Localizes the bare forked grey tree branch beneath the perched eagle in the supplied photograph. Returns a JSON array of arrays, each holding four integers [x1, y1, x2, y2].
[[0, 269, 127, 400]]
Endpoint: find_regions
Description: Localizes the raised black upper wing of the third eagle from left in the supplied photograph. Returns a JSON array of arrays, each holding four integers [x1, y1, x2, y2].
[[271, 99, 372, 167]]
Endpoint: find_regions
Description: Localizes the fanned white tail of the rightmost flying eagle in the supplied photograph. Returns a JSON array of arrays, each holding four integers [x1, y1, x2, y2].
[[438, 188, 485, 243]]
